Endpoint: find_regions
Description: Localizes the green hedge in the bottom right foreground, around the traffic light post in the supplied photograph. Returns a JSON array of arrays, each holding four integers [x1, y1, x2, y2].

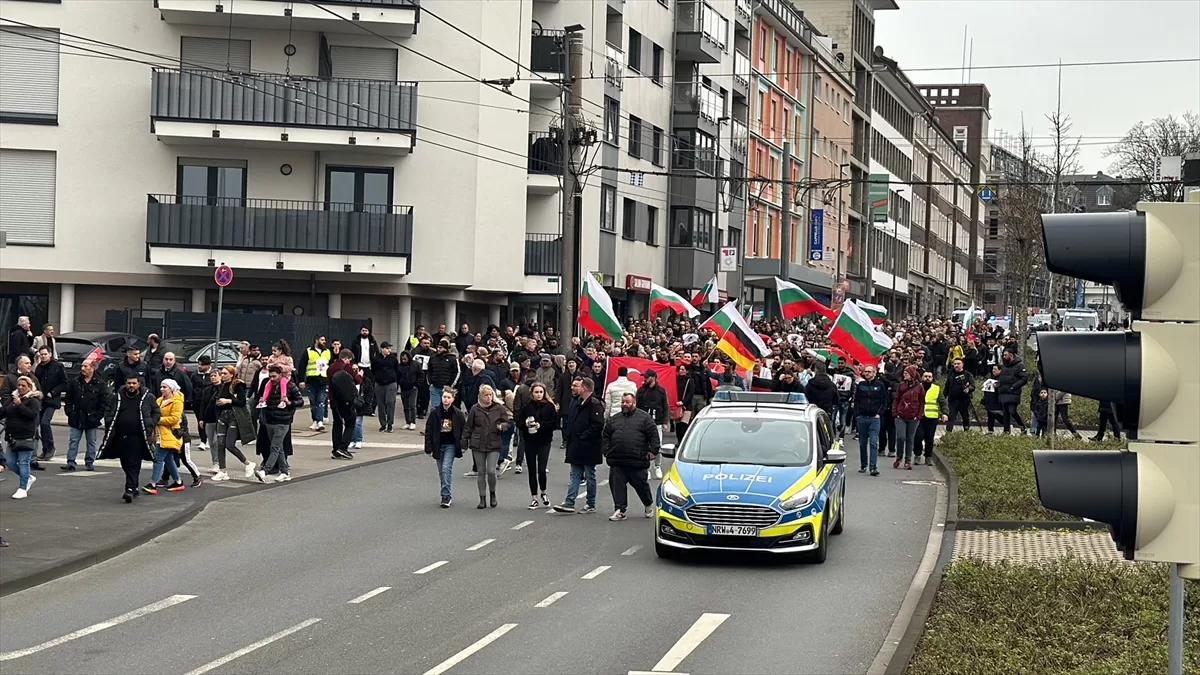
[[907, 558, 1200, 675]]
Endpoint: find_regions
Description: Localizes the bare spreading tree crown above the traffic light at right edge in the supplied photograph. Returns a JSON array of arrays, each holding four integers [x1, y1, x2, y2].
[[1104, 112, 1200, 202]]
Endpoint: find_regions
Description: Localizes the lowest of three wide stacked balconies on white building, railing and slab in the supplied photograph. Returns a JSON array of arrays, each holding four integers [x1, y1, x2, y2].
[[146, 195, 413, 275]]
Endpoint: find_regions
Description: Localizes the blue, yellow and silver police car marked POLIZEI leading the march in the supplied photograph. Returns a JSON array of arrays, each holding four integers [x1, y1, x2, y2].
[[654, 392, 846, 563]]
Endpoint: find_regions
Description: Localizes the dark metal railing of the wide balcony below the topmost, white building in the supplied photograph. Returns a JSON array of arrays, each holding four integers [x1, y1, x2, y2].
[[150, 68, 416, 132]]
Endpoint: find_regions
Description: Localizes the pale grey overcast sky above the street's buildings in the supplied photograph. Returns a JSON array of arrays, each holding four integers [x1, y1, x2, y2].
[[873, 0, 1200, 172]]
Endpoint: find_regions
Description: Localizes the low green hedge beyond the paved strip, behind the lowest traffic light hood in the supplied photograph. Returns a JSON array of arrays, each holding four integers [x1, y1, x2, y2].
[[936, 431, 1123, 520]]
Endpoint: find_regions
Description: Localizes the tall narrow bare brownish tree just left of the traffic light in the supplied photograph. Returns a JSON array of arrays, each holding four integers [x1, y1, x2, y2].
[[996, 125, 1049, 335]]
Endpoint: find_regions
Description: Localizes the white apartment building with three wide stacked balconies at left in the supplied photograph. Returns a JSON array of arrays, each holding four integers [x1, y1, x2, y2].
[[0, 0, 532, 339]]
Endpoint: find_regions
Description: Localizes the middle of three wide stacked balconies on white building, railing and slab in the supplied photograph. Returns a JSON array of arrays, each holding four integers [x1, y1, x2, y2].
[[150, 68, 416, 155]]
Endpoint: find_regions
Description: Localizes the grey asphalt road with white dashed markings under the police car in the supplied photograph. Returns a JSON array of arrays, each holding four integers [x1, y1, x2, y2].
[[0, 448, 936, 675]]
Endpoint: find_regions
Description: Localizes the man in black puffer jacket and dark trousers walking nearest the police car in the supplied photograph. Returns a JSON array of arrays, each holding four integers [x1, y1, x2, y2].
[[600, 394, 661, 521]]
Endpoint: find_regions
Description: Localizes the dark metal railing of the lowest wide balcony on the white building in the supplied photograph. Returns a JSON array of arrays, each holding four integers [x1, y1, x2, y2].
[[146, 195, 413, 257]]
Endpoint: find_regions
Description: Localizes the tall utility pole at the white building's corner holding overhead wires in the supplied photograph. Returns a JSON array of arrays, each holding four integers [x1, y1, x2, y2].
[[558, 31, 583, 352]]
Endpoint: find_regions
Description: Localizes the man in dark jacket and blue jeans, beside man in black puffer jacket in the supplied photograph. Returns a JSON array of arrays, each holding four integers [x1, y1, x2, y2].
[[554, 377, 604, 513]]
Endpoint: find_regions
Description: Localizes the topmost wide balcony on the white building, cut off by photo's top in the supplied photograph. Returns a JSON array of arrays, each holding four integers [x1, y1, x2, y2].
[[154, 0, 420, 37]]
